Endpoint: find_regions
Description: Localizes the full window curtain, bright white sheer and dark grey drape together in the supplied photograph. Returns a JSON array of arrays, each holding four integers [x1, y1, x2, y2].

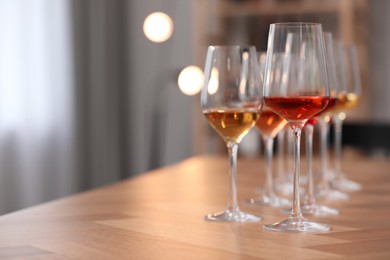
[[0, 0, 131, 214]]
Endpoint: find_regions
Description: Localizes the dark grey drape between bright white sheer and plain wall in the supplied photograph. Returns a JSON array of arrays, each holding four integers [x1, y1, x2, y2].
[[71, 0, 131, 188]]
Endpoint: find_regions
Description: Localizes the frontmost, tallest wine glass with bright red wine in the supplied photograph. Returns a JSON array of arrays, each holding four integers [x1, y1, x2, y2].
[[263, 23, 331, 232]]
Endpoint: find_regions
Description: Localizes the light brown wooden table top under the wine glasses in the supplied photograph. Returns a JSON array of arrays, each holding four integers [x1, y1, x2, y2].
[[0, 149, 390, 259]]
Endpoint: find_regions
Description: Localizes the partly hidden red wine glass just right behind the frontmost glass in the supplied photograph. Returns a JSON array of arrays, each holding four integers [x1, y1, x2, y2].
[[316, 33, 349, 200]]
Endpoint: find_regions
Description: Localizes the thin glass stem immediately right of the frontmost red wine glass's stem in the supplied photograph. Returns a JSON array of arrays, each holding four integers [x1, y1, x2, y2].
[[305, 124, 315, 205]]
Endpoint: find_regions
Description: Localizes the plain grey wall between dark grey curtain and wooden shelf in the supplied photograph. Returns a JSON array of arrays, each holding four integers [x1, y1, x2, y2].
[[128, 0, 198, 173]]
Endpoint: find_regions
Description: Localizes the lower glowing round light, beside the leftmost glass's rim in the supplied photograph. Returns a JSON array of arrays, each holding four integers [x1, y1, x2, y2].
[[177, 66, 203, 96]]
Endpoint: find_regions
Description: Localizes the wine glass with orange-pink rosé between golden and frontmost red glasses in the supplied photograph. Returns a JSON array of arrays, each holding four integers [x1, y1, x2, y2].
[[248, 52, 291, 207]]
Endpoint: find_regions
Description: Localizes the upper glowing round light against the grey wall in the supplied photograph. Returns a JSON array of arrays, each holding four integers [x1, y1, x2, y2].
[[144, 12, 173, 42]]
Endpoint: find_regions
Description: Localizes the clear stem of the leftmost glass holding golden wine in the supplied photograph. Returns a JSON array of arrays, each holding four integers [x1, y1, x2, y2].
[[227, 142, 239, 212]]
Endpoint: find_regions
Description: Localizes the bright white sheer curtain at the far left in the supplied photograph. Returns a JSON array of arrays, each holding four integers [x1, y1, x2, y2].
[[0, 0, 78, 213]]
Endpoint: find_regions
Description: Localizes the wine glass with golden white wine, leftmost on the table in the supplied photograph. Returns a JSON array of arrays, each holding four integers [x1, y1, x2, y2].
[[201, 46, 262, 222]]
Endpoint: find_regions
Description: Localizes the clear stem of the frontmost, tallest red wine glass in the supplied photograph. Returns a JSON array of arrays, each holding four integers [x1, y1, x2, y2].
[[290, 127, 303, 219]]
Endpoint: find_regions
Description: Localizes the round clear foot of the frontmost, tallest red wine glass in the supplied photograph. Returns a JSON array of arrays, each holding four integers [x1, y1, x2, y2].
[[263, 218, 331, 233]]
